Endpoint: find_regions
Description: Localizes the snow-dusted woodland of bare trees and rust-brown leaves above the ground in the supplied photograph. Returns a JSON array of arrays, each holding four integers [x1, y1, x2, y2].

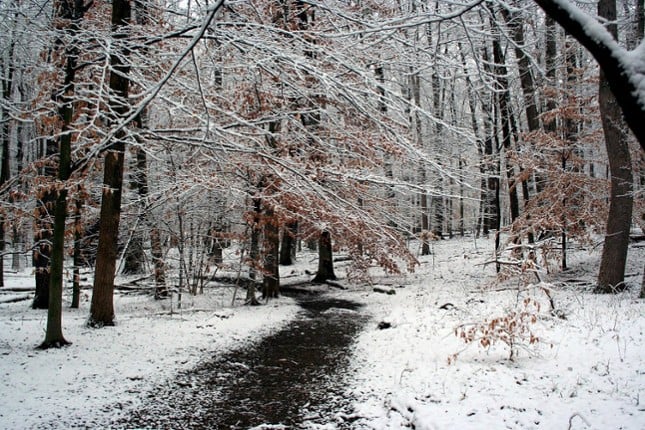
[[0, 0, 645, 348]]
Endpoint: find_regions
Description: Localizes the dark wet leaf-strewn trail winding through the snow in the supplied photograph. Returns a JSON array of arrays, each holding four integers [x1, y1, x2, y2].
[[118, 296, 367, 429]]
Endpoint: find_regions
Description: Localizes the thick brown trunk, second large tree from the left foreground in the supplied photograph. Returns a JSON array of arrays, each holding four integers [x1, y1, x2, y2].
[[88, 0, 131, 327]]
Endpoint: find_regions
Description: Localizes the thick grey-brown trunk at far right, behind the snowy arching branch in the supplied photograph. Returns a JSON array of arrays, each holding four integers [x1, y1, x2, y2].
[[594, 0, 633, 293]]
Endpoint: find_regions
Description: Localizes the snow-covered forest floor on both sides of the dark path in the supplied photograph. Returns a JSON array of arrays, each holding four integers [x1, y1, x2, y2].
[[0, 238, 645, 430]]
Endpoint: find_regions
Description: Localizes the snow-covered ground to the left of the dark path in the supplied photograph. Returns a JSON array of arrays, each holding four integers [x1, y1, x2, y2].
[[0, 289, 298, 430]]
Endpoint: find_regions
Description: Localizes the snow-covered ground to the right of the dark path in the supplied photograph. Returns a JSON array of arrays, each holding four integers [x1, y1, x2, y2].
[[344, 240, 645, 430]]
